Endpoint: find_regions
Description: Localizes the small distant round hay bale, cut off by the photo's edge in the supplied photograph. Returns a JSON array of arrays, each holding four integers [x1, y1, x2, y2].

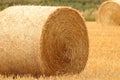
[[96, 0, 120, 25]]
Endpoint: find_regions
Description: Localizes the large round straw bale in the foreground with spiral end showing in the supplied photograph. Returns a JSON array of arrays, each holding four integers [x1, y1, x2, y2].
[[0, 6, 89, 75]]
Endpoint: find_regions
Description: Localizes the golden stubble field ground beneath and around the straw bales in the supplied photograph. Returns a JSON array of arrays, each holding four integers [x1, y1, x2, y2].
[[0, 22, 120, 80]]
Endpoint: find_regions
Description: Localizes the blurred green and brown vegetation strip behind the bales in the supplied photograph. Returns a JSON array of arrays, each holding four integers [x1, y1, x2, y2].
[[0, 0, 105, 21]]
